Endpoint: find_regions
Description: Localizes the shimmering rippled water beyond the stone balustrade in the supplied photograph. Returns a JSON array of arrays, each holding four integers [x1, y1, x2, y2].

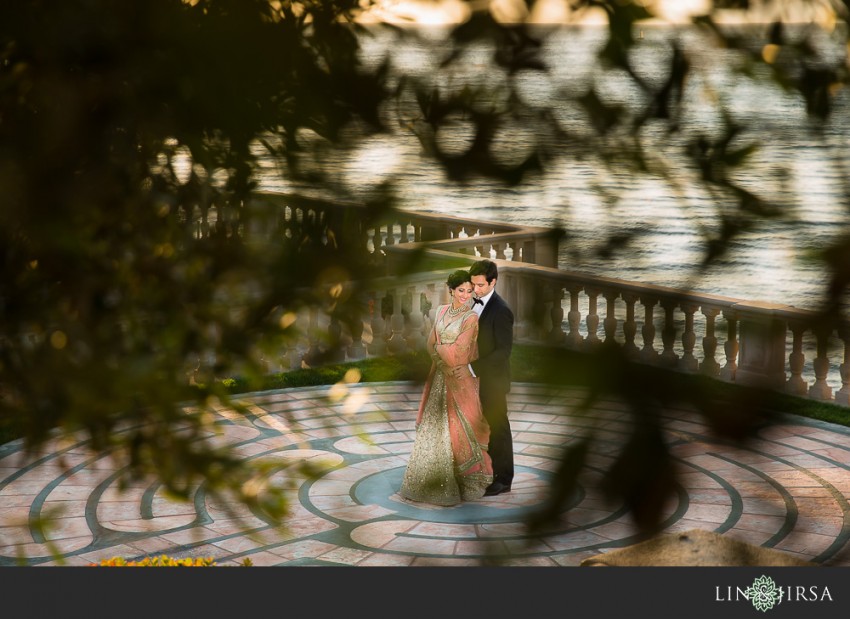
[[264, 28, 850, 309]]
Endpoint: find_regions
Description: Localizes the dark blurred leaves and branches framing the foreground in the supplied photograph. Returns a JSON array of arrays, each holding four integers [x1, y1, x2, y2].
[[0, 0, 850, 536]]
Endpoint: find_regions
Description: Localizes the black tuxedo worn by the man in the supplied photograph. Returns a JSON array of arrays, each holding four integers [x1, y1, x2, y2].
[[471, 291, 514, 487]]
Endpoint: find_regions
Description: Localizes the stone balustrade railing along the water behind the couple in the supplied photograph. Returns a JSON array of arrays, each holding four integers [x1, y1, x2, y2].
[[181, 194, 850, 406]]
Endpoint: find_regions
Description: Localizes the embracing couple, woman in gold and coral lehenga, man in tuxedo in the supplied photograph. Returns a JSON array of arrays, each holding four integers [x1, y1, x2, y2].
[[399, 260, 514, 505]]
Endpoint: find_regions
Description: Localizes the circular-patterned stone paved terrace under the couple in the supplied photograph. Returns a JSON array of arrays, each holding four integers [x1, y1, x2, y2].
[[0, 382, 850, 566]]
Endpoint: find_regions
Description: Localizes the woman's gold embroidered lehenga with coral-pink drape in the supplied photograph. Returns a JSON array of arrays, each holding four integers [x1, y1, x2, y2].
[[399, 305, 493, 505]]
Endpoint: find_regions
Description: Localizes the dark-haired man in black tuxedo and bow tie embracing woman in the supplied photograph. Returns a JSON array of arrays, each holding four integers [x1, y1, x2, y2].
[[454, 260, 514, 496]]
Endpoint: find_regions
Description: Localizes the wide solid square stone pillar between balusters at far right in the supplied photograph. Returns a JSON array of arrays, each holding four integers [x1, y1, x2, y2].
[[734, 302, 787, 389]]
